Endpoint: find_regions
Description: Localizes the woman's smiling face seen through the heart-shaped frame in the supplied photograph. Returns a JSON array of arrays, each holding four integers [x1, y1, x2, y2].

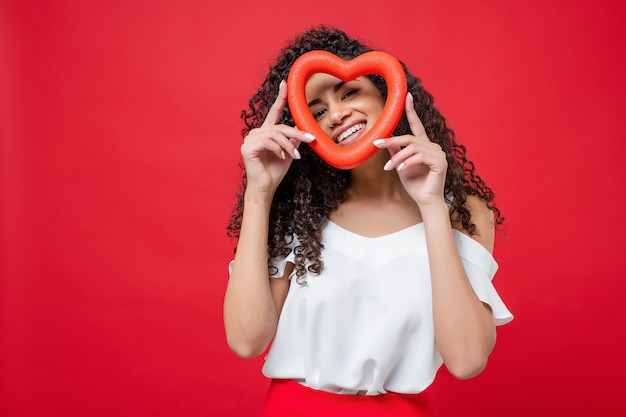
[[305, 73, 385, 146]]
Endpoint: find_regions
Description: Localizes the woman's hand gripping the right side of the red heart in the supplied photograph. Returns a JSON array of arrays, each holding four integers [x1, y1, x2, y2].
[[374, 93, 448, 207]]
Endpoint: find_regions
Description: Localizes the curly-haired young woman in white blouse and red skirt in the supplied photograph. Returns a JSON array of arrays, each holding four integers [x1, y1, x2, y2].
[[224, 26, 513, 416]]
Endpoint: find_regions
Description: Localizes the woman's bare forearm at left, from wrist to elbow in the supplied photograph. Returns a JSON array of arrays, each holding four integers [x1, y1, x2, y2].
[[224, 192, 278, 357]]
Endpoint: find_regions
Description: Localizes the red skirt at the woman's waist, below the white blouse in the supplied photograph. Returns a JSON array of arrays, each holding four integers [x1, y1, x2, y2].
[[261, 379, 430, 417]]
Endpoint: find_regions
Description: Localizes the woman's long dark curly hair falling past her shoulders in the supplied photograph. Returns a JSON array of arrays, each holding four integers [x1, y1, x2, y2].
[[227, 25, 504, 284]]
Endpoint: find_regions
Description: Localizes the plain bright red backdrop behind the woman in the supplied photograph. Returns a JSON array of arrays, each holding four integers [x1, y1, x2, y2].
[[0, 0, 626, 417]]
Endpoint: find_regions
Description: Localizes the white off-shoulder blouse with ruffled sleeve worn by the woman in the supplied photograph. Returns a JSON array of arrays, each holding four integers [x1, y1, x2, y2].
[[232, 221, 513, 395]]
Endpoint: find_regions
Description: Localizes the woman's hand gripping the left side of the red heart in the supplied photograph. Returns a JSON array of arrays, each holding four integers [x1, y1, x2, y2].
[[241, 81, 315, 198]]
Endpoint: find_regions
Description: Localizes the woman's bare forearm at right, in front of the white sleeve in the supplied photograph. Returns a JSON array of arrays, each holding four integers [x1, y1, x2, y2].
[[421, 201, 496, 378]]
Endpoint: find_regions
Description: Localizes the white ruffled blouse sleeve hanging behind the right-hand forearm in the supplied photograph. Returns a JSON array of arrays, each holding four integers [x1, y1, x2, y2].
[[454, 230, 513, 326]]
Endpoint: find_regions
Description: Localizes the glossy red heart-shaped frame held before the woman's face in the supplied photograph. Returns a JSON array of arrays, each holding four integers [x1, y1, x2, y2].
[[287, 51, 407, 169]]
